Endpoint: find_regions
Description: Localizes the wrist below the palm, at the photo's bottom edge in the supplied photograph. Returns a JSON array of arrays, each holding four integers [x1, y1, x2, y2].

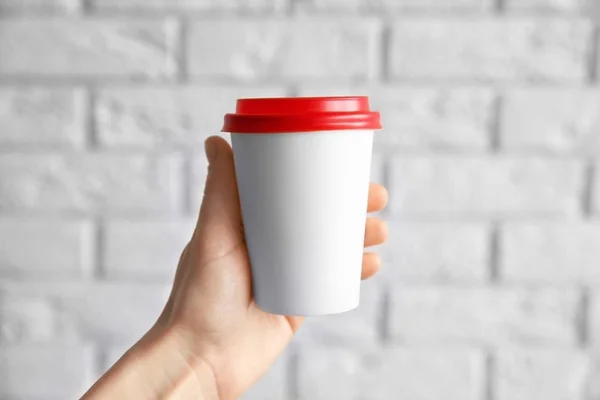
[[83, 328, 219, 400]]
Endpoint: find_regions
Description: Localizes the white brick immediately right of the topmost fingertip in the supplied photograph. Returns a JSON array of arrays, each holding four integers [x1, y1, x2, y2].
[[389, 155, 583, 217]]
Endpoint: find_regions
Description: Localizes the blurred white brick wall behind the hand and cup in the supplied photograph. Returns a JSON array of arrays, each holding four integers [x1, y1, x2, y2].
[[0, 0, 600, 400]]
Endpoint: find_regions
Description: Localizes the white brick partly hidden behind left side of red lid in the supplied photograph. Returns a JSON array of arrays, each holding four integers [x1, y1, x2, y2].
[[94, 85, 286, 149]]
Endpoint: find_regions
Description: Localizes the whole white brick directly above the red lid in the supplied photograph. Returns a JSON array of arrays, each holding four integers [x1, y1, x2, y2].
[[188, 19, 381, 81]]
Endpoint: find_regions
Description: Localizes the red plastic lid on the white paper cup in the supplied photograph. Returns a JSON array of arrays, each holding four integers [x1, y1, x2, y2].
[[222, 96, 381, 133]]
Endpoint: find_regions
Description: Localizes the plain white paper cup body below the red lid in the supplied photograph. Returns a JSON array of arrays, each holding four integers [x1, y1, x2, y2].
[[223, 97, 378, 315]]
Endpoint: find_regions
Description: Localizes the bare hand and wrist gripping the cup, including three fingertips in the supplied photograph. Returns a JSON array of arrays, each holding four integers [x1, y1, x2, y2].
[[82, 137, 387, 400]]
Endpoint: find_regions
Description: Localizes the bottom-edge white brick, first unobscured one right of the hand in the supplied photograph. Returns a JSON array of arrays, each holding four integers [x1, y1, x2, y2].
[[299, 347, 484, 400]]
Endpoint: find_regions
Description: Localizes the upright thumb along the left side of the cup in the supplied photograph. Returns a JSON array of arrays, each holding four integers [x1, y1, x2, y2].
[[192, 136, 244, 262]]
